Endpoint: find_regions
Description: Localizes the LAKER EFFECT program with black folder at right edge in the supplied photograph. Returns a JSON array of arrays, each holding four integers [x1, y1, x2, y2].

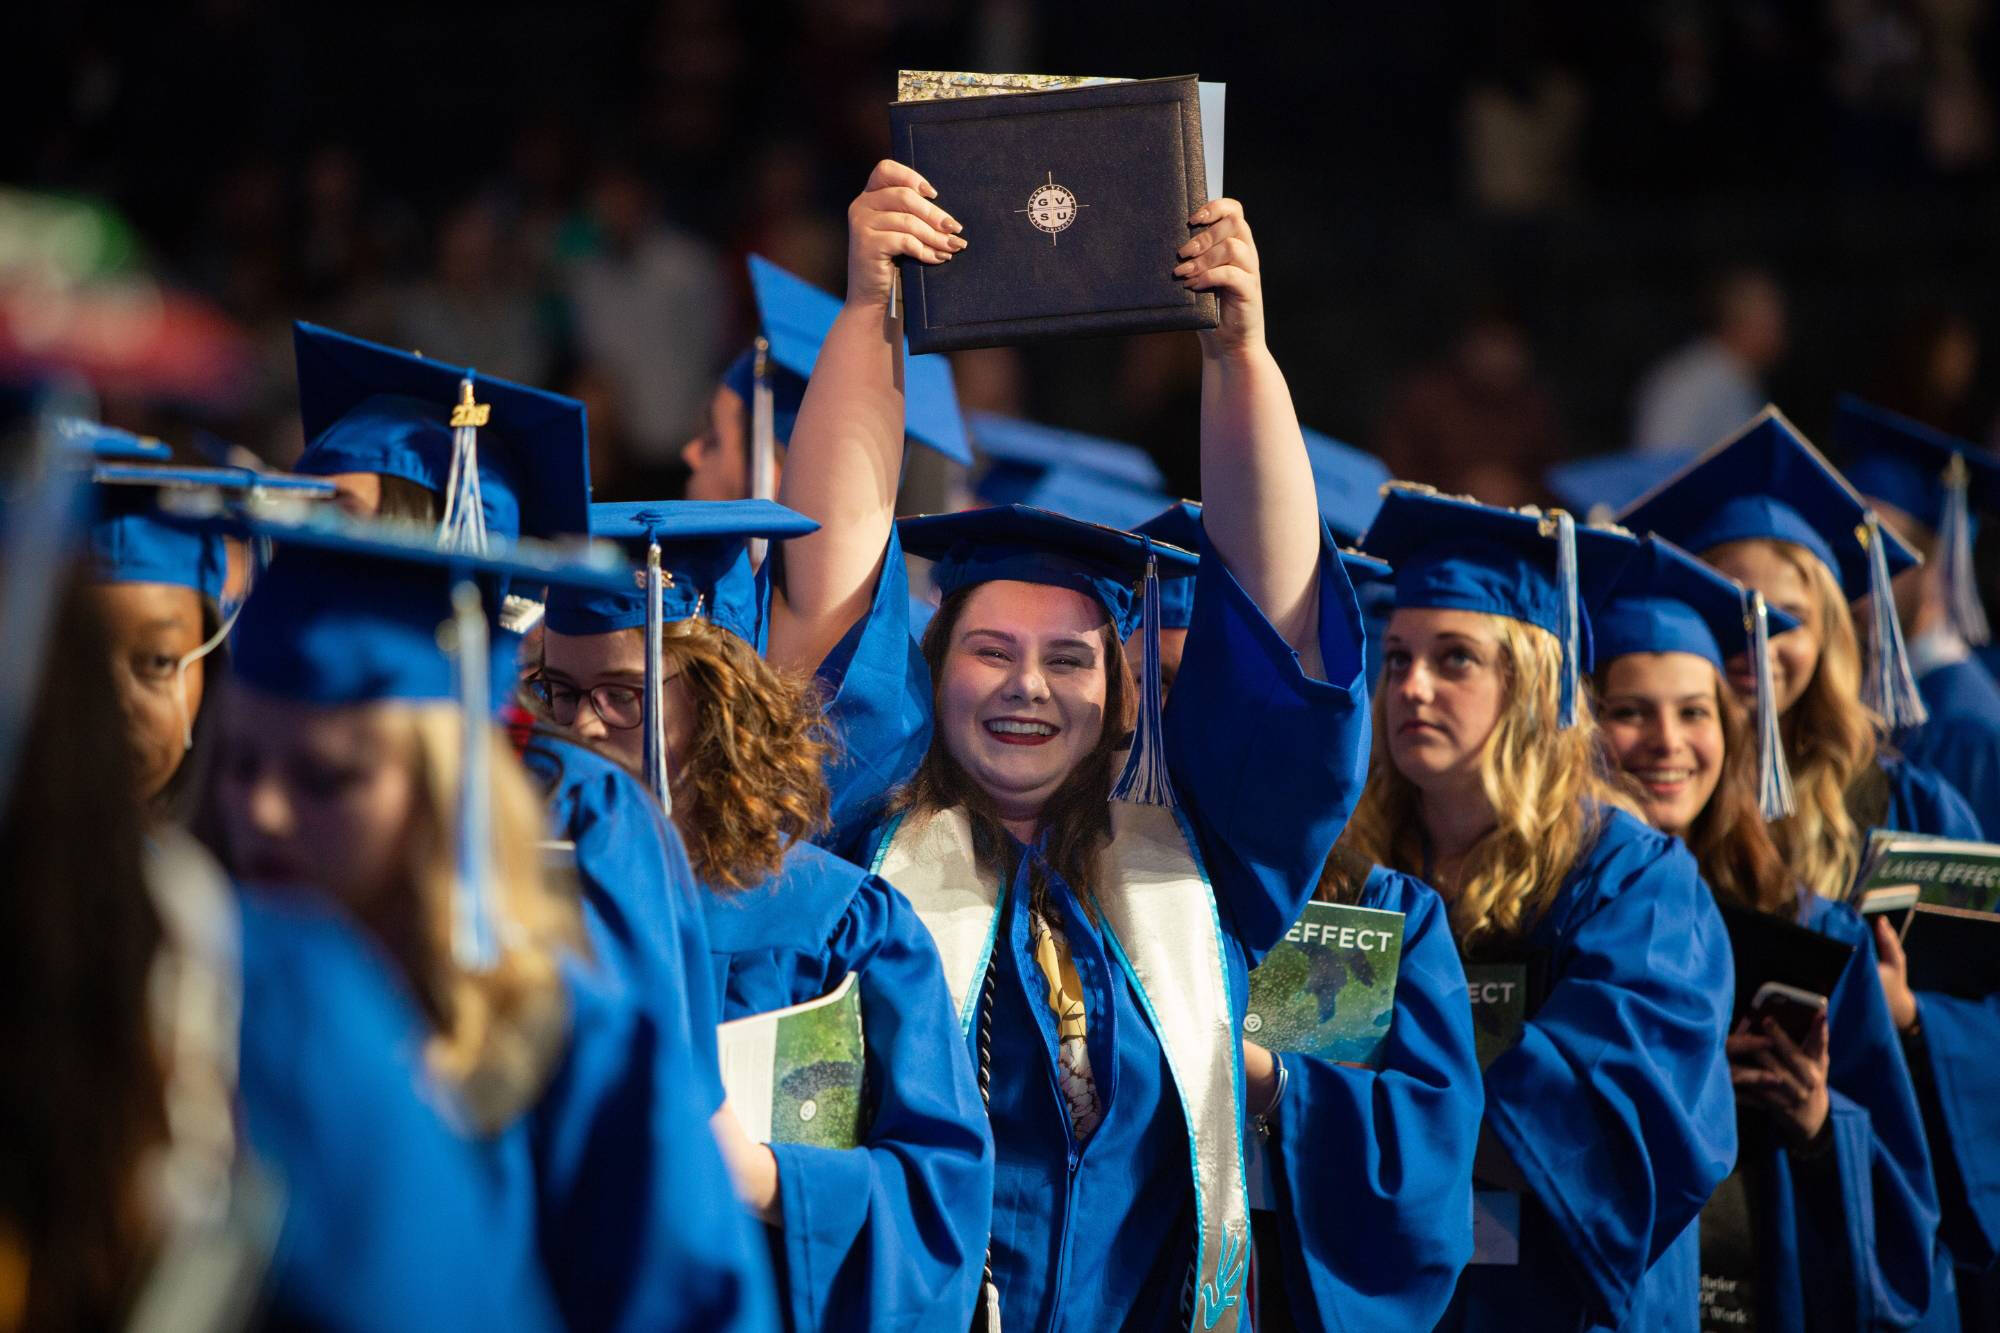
[[1852, 829, 2000, 999]]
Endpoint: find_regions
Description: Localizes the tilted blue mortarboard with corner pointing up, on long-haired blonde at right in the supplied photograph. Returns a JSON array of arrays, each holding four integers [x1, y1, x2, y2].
[[1618, 406, 1916, 600]]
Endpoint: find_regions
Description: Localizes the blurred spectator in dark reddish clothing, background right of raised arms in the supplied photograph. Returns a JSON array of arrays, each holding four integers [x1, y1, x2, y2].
[[1376, 304, 1562, 504]]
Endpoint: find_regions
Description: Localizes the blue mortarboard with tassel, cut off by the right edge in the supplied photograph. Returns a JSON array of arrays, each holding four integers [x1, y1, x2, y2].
[[1834, 394, 2000, 644]]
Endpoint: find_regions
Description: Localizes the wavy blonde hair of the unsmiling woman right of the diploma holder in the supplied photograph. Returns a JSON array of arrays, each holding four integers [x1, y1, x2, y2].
[[1340, 614, 1638, 957]]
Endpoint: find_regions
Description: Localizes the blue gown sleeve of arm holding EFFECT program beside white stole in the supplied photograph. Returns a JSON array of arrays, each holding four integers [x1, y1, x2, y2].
[[1270, 869, 1484, 1333]]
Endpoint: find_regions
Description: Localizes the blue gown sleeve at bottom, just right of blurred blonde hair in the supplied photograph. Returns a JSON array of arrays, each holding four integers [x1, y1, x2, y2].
[[526, 965, 776, 1333]]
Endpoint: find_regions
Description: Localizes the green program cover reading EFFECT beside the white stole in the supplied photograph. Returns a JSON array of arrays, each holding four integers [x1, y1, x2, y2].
[[1244, 903, 1402, 1067]]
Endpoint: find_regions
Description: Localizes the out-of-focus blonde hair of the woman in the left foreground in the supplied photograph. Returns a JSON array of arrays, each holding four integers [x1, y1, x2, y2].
[[380, 703, 588, 1133]]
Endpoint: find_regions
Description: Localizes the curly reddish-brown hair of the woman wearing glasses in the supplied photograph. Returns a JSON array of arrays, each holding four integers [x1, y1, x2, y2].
[[660, 618, 832, 891]]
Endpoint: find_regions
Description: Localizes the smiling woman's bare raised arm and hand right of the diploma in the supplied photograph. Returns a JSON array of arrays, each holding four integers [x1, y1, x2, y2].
[[1174, 198, 1326, 679]]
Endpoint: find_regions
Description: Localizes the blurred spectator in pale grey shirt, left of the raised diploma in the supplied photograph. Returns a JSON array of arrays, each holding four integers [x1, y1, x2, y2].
[[566, 164, 734, 464]]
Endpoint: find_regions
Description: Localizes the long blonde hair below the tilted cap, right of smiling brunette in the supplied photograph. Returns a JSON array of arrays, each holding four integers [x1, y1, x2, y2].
[[1728, 538, 1886, 899]]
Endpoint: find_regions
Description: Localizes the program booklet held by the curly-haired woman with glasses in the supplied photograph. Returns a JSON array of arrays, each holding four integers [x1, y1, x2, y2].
[[716, 973, 864, 1149]]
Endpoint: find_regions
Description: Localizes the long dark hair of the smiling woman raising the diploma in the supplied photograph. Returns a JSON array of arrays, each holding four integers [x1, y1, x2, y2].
[[892, 584, 1138, 909]]
